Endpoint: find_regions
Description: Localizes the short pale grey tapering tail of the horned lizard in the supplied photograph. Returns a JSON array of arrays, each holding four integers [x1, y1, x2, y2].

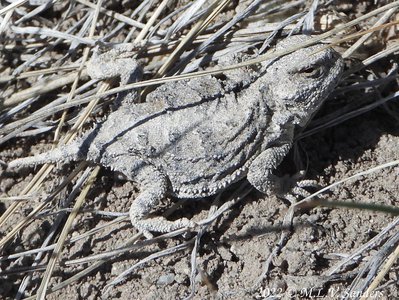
[[7, 142, 85, 168]]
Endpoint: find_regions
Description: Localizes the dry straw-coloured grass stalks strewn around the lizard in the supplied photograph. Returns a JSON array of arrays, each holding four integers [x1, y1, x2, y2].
[[0, 0, 399, 299]]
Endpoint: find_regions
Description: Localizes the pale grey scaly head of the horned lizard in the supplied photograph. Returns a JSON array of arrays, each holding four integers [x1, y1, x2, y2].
[[264, 35, 343, 126]]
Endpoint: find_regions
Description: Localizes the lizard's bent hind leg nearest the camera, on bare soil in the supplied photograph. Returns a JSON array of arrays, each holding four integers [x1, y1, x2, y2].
[[113, 156, 193, 238]]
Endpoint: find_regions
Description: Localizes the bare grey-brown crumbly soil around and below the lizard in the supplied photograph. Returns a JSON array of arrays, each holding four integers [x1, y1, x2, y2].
[[0, 85, 399, 299]]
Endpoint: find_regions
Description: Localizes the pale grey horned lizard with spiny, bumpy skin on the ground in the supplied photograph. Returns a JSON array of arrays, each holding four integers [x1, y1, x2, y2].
[[9, 35, 343, 236]]
